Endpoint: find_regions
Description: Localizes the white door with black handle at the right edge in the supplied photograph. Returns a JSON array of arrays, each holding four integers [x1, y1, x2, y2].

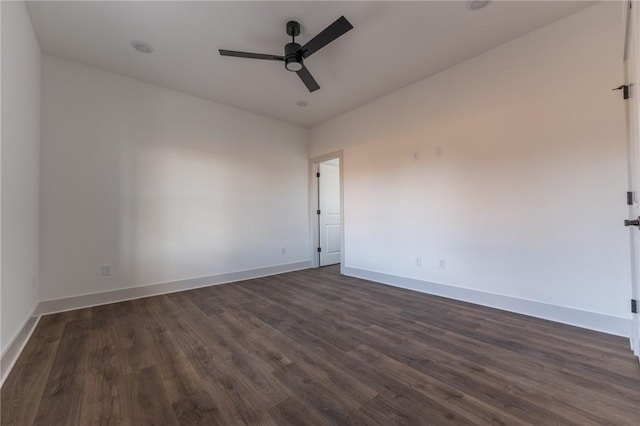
[[625, 1, 640, 357]]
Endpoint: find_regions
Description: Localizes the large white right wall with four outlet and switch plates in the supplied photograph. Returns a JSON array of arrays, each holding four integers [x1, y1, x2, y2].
[[311, 2, 631, 326]]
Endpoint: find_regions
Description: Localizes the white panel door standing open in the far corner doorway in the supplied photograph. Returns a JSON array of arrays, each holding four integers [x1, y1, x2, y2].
[[318, 158, 342, 266]]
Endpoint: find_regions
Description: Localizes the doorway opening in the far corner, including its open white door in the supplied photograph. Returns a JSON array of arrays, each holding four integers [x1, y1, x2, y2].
[[311, 153, 343, 267]]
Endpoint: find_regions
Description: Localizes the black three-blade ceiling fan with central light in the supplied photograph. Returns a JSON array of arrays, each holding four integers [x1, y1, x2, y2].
[[219, 16, 353, 92]]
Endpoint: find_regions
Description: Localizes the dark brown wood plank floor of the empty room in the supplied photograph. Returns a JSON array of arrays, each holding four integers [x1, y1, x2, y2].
[[1, 267, 640, 426]]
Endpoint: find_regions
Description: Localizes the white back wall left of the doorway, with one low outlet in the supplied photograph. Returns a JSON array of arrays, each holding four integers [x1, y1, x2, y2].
[[41, 56, 309, 300]]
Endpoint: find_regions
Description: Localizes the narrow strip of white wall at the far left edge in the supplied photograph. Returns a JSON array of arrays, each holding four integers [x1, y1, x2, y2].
[[0, 2, 40, 351]]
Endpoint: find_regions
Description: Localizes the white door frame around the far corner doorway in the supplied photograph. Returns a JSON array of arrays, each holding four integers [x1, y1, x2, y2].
[[309, 150, 345, 273]]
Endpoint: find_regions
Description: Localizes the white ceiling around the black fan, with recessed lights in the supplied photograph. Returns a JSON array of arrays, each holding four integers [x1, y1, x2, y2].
[[28, 1, 593, 126]]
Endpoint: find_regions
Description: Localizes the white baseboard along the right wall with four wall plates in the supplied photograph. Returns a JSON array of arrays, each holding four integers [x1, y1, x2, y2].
[[342, 267, 631, 337]]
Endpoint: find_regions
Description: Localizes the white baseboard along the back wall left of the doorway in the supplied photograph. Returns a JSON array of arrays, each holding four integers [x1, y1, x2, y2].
[[37, 261, 310, 315]]
